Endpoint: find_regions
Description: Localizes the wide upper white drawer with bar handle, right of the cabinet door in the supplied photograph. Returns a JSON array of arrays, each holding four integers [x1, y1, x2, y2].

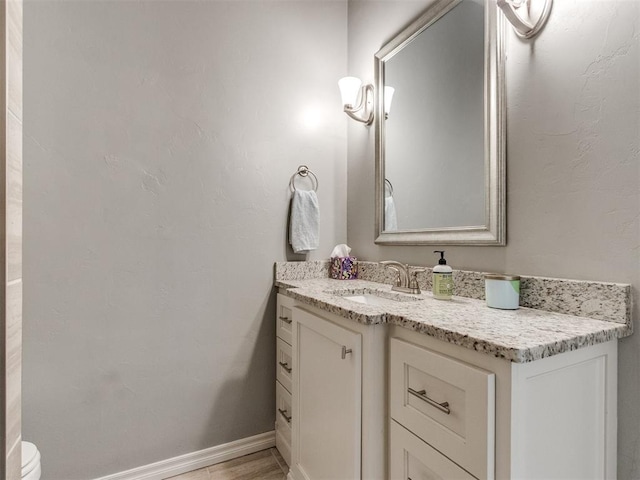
[[390, 338, 495, 480]]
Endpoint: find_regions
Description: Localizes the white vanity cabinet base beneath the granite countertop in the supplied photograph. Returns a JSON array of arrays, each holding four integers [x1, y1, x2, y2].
[[276, 288, 617, 480]]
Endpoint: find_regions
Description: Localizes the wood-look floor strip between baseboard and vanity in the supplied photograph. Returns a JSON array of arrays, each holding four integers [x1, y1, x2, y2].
[[167, 448, 289, 480]]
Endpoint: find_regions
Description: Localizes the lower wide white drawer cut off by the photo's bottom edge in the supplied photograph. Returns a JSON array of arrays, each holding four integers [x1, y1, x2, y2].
[[389, 420, 475, 480]]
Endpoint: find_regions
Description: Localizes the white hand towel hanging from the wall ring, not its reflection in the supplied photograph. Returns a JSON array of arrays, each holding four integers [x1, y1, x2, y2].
[[289, 190, 320, 253]]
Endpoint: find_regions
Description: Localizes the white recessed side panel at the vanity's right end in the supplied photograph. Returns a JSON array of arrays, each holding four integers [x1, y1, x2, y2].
[[511, 341, 618, 480]]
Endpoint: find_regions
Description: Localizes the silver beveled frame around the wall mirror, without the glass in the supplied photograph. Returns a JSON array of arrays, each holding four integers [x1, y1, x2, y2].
[[375, 0, 506, 245]]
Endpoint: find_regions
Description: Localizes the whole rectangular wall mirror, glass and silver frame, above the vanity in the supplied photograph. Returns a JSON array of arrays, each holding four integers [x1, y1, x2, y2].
[[375, 0, 506, 245]]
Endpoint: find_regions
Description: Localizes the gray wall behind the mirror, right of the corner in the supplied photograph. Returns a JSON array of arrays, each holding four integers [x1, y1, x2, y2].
[[347, 0, 640, 479]]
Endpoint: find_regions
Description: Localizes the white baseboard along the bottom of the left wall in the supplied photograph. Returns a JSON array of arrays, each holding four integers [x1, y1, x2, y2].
[[96, 431, 276, 480]]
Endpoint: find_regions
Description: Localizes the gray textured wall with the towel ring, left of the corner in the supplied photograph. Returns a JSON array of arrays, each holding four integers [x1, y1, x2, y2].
[[23, 0, 347, 480]]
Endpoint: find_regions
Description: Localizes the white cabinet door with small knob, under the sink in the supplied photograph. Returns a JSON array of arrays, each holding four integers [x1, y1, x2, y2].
[[291, 308, 362, 480]]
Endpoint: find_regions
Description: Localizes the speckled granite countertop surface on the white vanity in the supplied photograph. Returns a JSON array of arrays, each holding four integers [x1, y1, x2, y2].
[[276, 278, 632, 363]]
